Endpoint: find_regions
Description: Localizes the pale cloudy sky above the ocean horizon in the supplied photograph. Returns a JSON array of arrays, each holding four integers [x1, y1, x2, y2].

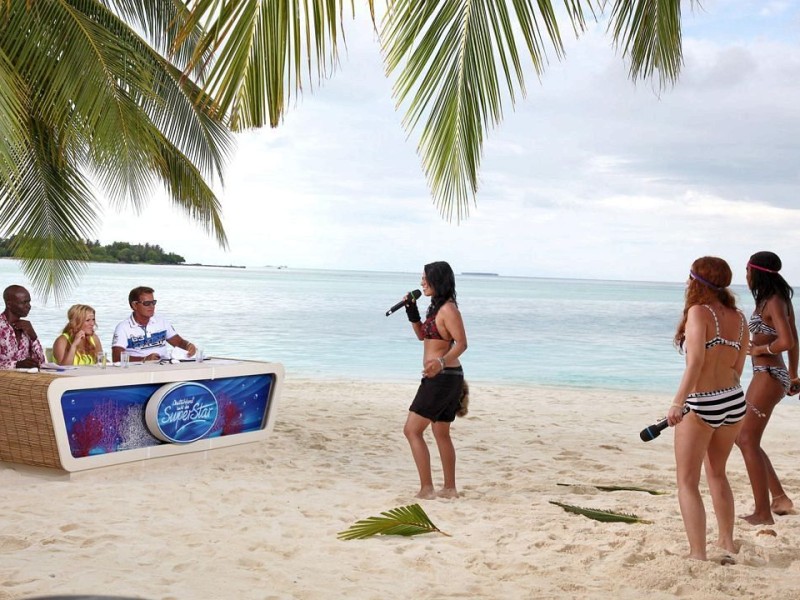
[[97, 0, 800, 286]]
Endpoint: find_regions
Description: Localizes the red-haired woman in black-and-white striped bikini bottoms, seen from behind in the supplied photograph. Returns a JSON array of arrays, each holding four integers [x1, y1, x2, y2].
[[667, 256, 748, 564]]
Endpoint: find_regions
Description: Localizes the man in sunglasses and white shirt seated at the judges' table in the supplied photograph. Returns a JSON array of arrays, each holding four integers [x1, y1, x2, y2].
[[111, 286, 197, 362]]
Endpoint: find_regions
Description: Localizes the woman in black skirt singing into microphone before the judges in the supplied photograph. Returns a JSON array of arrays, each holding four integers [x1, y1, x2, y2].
[[403, 262, 467, 499]]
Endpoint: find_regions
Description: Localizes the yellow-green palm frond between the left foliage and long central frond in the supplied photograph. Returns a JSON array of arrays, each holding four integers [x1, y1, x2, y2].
[[183, 0, 374, 131]]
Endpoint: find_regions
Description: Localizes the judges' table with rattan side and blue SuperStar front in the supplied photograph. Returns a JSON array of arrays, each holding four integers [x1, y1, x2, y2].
[[0, 358, 284, 471]]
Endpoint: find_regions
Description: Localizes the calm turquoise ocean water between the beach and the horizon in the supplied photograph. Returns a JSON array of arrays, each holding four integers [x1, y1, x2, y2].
[[0, 260, 752, 392]]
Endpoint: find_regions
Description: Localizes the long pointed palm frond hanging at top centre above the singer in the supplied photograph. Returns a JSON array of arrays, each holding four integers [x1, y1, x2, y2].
[[381, 0, 583, 221]]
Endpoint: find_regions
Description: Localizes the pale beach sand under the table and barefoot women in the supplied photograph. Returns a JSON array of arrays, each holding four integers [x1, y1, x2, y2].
[[0, 378, 800, 600]]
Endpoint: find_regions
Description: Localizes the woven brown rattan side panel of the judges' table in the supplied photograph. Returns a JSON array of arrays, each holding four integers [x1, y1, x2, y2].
[[0, 370, 61, 468]]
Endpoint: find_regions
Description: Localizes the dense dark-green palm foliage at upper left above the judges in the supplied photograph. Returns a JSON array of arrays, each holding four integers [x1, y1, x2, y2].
[[0, 0, 231, 299]]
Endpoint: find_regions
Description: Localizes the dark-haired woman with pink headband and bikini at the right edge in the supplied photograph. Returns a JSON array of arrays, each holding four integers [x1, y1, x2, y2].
[[736, 252, 800, 525]]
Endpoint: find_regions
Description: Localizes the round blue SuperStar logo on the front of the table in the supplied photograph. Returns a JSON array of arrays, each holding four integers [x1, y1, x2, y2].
[[145, 381, 219, 444]]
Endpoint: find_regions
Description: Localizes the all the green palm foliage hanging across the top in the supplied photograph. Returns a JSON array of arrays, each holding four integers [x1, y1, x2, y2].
[[0, 0, 694, 294]]
